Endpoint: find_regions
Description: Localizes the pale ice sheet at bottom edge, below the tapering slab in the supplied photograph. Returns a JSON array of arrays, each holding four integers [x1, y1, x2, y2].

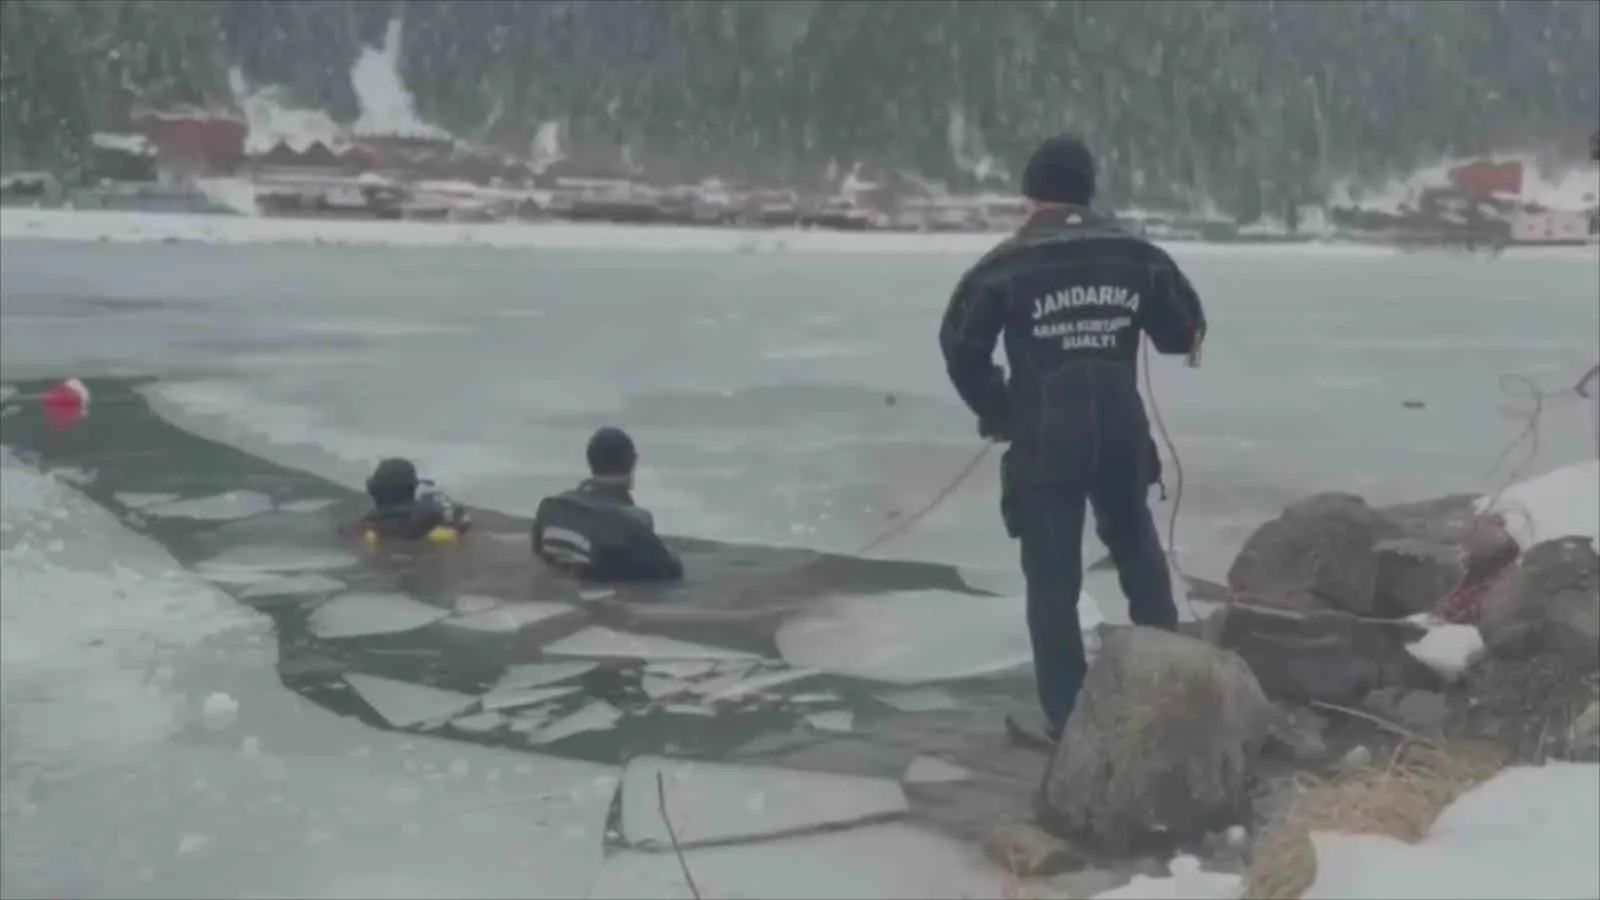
[[589, 819, 1006, 900]]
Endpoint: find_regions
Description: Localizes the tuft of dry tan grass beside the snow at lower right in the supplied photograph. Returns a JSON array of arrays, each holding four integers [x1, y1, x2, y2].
[[1245, 741, 1506, 900]]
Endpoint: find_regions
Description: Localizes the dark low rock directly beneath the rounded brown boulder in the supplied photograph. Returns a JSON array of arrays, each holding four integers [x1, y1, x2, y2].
[[1205, 604, 1437, 703]]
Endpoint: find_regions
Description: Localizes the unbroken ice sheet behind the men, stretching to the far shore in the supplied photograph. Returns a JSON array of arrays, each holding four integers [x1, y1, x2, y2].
[[0, 240, 1600, 578]]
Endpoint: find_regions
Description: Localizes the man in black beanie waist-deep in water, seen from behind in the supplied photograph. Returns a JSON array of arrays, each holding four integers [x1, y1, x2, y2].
[[533, 428, 683, 581]]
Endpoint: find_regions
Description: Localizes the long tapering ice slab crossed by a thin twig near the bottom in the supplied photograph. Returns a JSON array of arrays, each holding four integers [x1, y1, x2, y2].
[[622, 756, 910, 849]]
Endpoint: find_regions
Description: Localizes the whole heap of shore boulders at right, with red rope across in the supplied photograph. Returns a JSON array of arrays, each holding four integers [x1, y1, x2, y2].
[[986, 474, 1600, 897]]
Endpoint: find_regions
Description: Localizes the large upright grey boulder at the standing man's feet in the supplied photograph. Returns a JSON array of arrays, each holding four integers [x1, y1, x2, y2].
[[1042, 628, 1278, 852]]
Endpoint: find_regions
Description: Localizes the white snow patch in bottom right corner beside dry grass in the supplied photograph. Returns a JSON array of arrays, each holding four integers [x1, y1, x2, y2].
[[1306, 762, 1600, 900]]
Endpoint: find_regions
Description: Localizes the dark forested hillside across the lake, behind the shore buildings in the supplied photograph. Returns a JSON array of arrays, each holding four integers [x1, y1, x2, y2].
[[0, 0, 1600, 221]]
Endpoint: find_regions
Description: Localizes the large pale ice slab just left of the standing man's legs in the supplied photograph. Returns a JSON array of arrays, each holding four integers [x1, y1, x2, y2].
[[776, 591, 1032, 684]]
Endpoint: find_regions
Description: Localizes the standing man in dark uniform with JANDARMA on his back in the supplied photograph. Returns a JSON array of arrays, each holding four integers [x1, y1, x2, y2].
[[939, 135, 1205, 738]]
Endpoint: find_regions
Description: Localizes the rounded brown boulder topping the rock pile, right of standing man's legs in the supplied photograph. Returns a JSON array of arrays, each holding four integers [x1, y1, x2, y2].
[[1227, 493, 1400, 615]]
